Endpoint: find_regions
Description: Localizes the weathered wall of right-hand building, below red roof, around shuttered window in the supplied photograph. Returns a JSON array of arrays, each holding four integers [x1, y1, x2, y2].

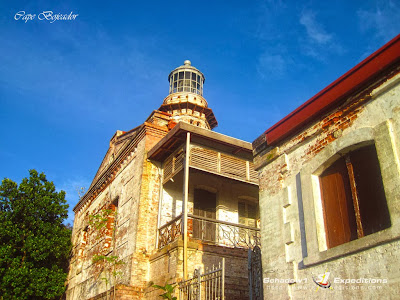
[[255, 71, 400, 299]]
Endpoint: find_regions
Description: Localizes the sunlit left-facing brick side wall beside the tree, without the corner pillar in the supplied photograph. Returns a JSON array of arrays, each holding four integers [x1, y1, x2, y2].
[[67, 141, 145, 299]]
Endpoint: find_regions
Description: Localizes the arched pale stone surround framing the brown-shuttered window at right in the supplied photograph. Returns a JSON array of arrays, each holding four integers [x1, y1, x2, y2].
[[294, 125, 400, 266]]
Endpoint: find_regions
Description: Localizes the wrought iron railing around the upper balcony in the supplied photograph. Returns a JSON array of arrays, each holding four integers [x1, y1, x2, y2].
[[158, 215, 261, 249]]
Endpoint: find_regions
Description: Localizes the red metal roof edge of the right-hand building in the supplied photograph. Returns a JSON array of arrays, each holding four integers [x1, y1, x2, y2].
[[264, 34, 400, 145]]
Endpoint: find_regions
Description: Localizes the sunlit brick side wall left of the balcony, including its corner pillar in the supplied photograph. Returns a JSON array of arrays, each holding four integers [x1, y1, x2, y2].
[[67, 112, 168, 299]]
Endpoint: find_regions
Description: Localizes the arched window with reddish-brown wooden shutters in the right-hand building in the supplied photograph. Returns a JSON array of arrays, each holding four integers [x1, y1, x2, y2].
[[319, 145, 391, 248]]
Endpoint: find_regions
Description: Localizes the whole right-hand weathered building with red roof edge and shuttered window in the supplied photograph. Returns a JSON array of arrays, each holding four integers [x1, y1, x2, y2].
[[253, 36, 400, 299]]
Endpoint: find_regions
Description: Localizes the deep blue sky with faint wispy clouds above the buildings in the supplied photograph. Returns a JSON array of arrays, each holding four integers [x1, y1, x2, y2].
[[0, 0, 400, 222]]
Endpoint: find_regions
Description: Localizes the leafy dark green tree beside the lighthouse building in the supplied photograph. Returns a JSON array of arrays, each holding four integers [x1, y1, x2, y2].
[[0, 170, 71, 299]]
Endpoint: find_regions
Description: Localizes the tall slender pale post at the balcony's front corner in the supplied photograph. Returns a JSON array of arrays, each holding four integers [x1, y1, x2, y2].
[[182, 132, 190, 280]]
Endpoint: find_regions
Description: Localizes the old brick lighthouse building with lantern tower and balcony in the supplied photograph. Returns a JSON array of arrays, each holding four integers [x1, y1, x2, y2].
[[67, 61, 259, 299]]
